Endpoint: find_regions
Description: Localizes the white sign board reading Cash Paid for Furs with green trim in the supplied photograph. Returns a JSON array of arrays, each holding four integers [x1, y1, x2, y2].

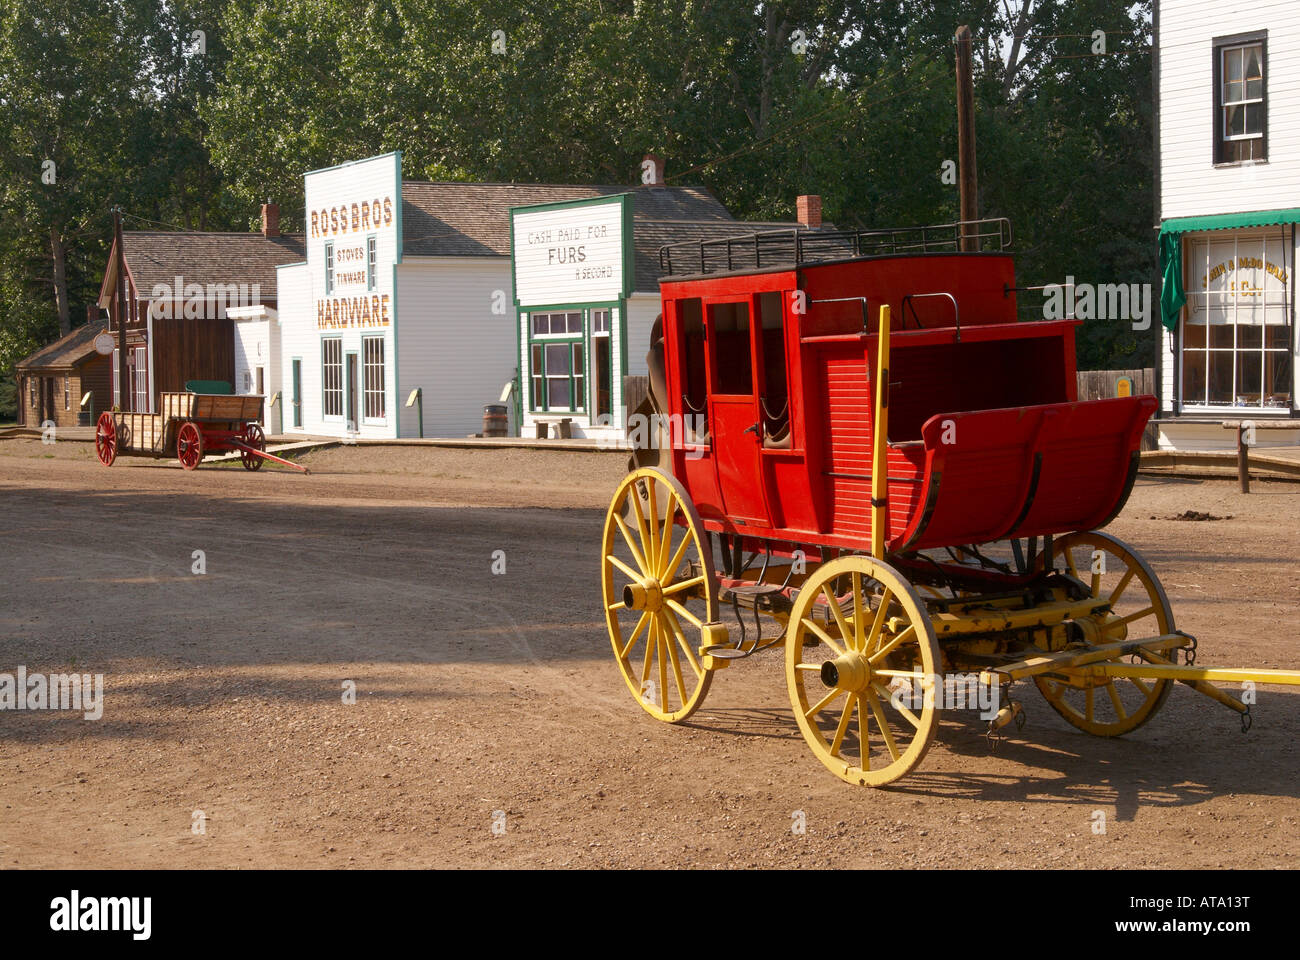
[[510, 194, 633, 307]]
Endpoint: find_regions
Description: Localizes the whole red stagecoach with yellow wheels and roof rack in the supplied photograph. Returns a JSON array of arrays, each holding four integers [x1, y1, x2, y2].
[[601, 221, 1300, 786]]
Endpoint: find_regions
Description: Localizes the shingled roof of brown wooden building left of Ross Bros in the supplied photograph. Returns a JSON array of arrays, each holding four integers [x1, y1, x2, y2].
[[100, 230, 307, 306]]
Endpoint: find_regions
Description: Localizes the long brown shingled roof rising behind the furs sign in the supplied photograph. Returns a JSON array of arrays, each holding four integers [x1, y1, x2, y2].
[[402, 181, 774, 291]]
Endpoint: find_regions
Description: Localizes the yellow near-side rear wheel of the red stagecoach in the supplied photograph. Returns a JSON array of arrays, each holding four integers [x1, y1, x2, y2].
[[601, 467, 718, 723]]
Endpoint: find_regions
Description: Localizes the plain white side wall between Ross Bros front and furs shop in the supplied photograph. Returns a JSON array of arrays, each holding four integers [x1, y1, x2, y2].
[[395, 256, 517, 437]]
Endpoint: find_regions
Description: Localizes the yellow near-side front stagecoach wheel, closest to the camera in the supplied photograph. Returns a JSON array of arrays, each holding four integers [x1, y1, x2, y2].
[[785, 555, 941, 787]]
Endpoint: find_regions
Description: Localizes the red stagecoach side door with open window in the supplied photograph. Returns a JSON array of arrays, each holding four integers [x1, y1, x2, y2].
[[705, 299, 771, 527]]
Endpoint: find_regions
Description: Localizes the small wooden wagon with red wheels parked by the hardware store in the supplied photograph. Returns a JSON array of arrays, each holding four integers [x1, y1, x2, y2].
[[95, 390, 307, 473]]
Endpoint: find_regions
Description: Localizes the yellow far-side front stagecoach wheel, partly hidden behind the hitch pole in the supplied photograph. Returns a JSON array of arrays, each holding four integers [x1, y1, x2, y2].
[[1034, 531, 1174, 736]]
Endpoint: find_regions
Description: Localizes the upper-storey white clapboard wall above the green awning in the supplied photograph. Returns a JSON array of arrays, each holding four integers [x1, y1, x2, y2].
[[1157, 0, 1300, 219]]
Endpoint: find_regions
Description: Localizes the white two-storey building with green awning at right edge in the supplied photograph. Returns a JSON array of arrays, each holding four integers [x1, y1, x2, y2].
[[1156, 0, 1300, 450]]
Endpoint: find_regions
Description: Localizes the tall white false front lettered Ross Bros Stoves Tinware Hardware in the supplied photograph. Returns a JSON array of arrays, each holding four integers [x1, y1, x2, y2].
[[304, 153, 402, 330]]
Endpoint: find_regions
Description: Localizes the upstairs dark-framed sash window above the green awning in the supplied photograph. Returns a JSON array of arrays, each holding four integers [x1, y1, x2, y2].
[[1214, 35, 1268, 163]]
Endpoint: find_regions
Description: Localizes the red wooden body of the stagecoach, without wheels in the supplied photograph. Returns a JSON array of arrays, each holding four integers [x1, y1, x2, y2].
[[660, 254, 1156, 553]]
